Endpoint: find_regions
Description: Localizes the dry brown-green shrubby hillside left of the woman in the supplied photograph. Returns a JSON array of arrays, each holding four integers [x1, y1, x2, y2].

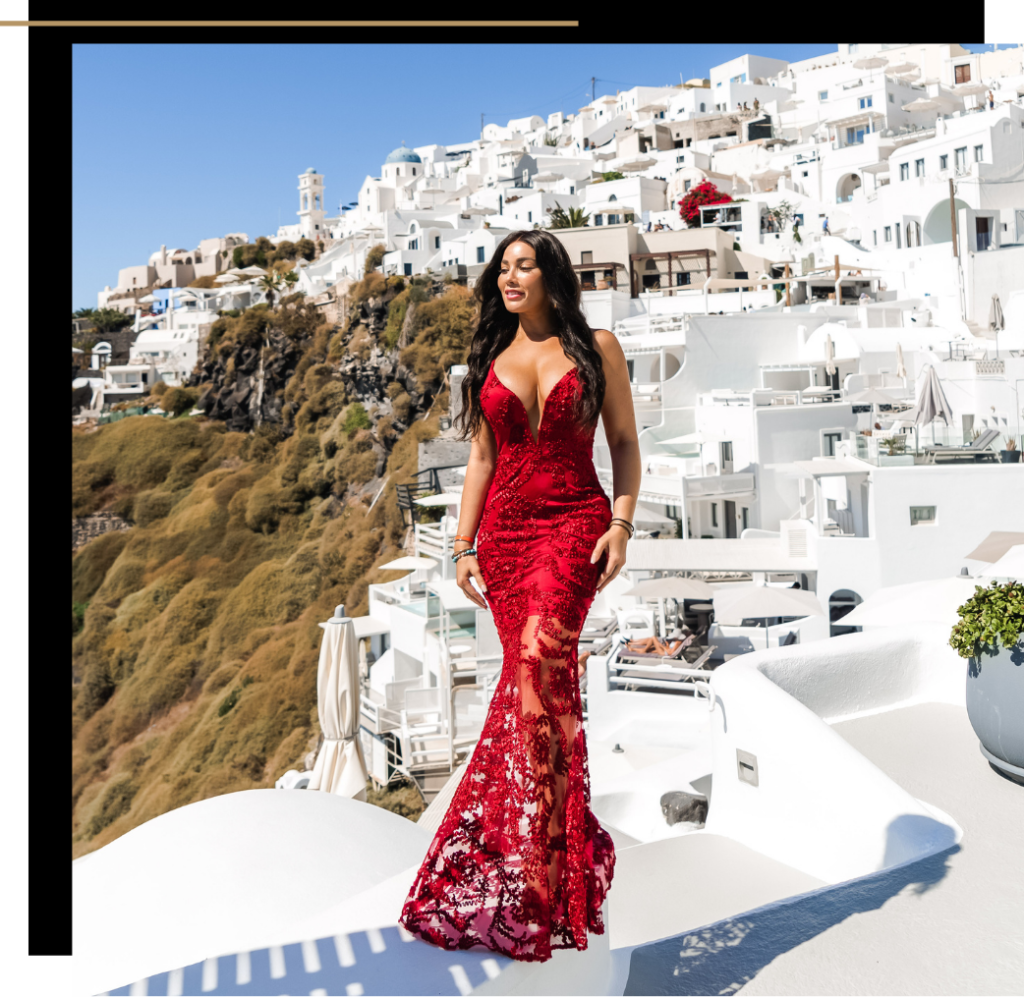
[[72, 273, 474, 856]]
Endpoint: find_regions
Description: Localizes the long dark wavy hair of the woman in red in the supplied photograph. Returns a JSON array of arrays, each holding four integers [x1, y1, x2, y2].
[[456, 228, 604, 439]]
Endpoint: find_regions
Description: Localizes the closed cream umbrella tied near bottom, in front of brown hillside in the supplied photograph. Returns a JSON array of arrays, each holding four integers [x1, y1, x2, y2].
[[307, 606, 368, 801]]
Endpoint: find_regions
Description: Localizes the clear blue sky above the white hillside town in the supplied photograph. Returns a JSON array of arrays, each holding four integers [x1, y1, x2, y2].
[[72, 44, 1007, 308]]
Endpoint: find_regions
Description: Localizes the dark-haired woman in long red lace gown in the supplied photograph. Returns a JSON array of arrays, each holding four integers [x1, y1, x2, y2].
[[401, 229, 640, 961]]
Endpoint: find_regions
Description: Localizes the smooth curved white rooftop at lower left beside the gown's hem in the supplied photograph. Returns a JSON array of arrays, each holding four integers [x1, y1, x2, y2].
[[73, 789, 431, 994]]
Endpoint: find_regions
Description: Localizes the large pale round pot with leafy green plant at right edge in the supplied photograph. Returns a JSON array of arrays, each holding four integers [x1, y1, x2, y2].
[[949, 581, 1024, 785]]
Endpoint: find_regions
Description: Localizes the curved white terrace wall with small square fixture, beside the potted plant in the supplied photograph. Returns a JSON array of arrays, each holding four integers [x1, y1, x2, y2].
[[705, 631, 965, 883]]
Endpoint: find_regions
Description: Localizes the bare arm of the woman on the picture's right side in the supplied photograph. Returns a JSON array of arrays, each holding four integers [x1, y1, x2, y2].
[[591, 329, 641, 592]]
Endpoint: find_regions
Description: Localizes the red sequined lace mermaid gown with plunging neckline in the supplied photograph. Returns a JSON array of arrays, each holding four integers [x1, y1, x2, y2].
[[400, 356, 615, 961]]
